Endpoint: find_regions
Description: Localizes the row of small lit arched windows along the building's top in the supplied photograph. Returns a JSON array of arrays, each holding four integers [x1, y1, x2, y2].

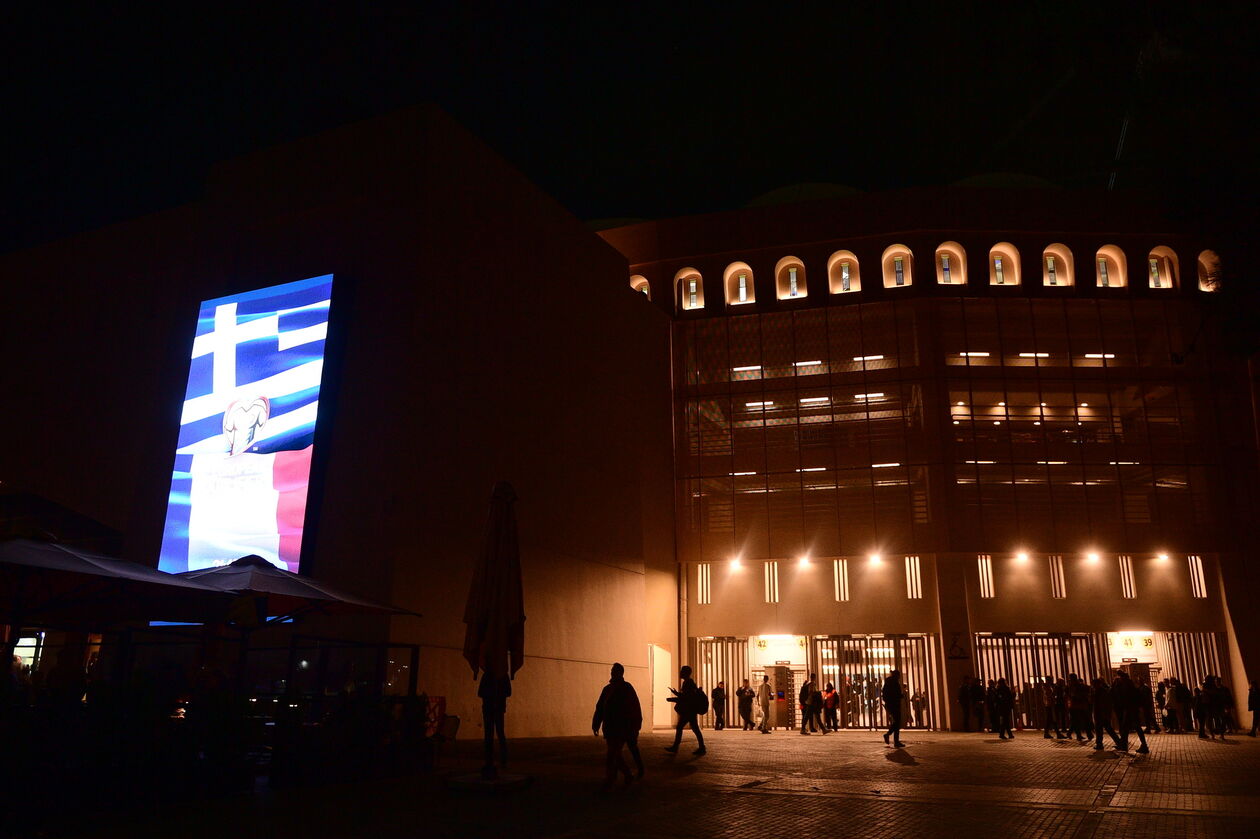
[[630, 242, 1221, 309]]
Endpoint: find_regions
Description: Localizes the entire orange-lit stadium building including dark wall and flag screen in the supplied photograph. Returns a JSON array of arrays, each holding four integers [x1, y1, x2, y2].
[[0, 108, 1260, 736]]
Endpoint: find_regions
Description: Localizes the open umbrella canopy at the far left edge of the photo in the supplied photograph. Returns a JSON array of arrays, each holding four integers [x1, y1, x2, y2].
[[0, 539, 231, 627]]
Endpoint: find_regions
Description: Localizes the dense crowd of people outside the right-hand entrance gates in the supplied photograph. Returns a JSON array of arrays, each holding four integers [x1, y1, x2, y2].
[[956, 670, 1257, 753]]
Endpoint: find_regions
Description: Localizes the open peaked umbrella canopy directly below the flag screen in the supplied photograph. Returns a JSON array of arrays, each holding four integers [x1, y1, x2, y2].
[[175, 556, 418, 616]]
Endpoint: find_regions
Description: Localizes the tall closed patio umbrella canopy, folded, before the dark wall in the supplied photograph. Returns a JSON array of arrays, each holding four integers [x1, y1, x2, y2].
[[464, 481, 525, 678]]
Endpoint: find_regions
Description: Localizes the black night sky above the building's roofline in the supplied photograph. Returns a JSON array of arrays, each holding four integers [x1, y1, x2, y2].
[[0, 0, 1257, 252]]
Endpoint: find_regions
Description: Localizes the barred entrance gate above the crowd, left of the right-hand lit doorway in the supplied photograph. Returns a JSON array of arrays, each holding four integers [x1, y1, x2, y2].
[[975, 632, 1110, 728]]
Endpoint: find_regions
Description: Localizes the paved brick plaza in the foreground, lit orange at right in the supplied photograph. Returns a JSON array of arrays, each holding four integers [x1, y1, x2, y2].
[[54, 714, 1260, 839]]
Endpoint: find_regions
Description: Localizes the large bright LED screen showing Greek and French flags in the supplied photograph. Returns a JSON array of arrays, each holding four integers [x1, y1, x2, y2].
[[159, 275, 333, 572]]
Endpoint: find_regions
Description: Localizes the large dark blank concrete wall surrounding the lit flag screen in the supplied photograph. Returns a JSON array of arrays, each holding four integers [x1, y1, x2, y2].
[[0, 102, 677, 736]]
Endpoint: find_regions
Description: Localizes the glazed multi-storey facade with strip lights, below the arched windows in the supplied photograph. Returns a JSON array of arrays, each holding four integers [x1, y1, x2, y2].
[[674, 297, 1221, 561]]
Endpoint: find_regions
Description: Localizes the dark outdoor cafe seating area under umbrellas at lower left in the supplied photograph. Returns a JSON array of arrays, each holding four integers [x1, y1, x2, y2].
[[0, 539, 443, 833]]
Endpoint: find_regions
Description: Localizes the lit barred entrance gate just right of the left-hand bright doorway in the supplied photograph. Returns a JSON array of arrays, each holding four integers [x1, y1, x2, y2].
[[793, 635, 940, 729]]
